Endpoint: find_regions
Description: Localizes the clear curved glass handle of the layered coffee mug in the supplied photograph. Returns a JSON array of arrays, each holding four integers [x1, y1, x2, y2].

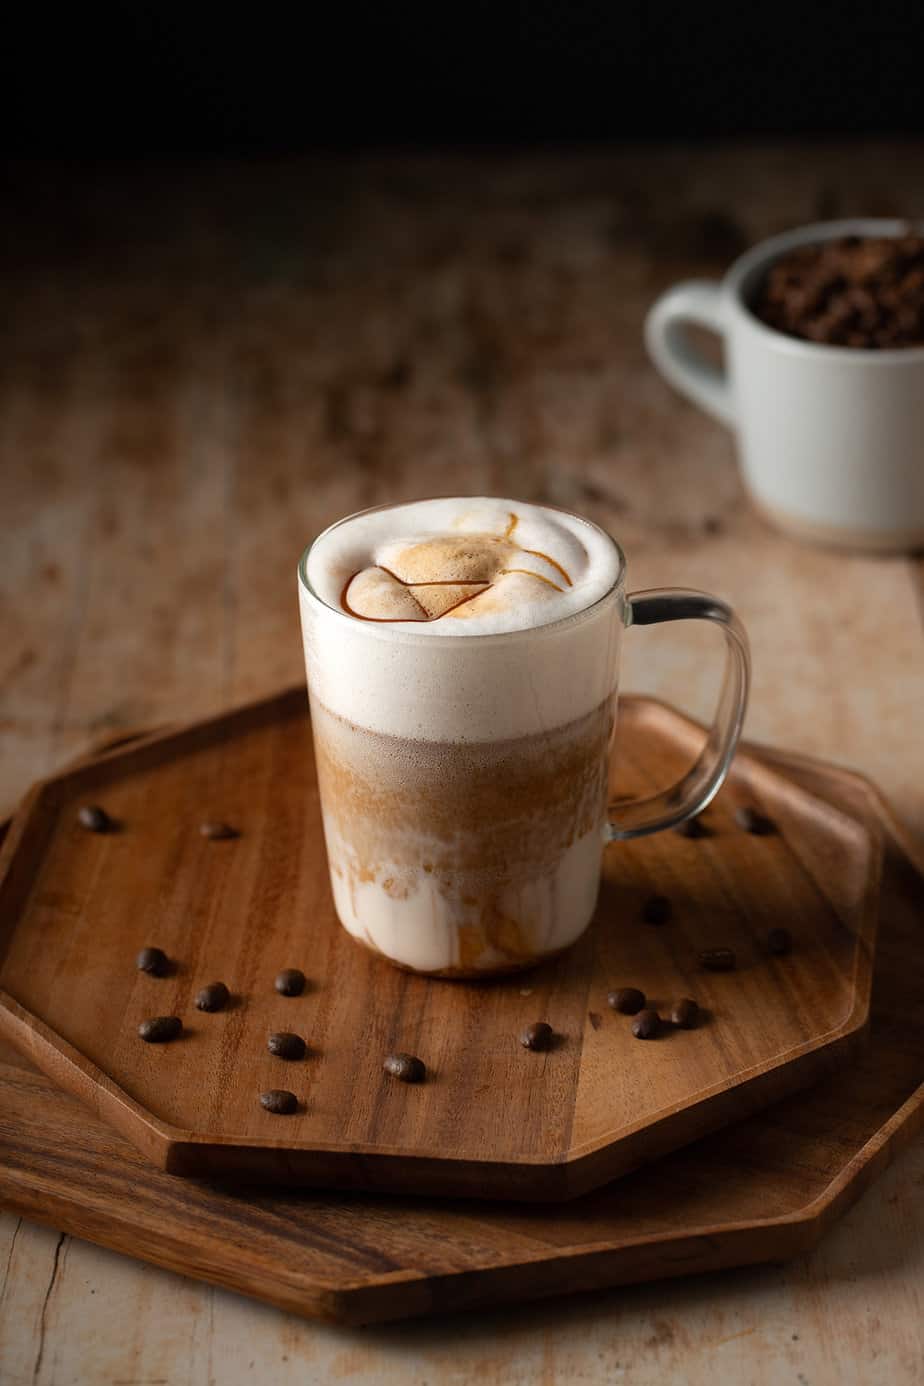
[[607, 588, 751, 843]]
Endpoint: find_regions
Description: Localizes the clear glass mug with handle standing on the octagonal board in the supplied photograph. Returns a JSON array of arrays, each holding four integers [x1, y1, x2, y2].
[[298, 498, 749, 977]]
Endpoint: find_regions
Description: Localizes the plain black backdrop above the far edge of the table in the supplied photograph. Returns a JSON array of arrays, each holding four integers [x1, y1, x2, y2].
[[0, 0, 924, 155]]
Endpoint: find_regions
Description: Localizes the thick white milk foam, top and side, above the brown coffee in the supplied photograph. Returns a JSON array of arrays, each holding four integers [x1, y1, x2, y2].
[[299, 498, 626, 743]]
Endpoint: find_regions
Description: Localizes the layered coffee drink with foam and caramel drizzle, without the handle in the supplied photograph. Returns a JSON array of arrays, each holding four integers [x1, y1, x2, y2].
[[299, 498, 623, 976]]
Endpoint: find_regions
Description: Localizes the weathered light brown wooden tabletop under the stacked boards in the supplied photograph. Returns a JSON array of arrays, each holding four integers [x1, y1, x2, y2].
[[0, 144, 924, 1386]]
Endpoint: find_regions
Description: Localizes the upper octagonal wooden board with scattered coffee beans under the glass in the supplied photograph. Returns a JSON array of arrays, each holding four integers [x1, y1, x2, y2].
[[0, 692, 881, 1199]]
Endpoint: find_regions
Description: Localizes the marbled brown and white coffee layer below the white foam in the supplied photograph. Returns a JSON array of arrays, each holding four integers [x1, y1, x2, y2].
[[312, 697, 615, 973]]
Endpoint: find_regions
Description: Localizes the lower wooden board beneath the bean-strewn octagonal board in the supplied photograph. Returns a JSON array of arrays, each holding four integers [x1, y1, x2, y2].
[[0, 742, 924, 1324]]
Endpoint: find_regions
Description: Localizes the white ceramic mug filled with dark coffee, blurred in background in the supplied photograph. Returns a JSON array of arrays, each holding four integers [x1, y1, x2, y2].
[[646, 219, 924, 552]]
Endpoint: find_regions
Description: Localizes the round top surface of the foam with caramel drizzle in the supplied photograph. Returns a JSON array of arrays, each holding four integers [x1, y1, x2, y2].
[[308, 498, 619, 636]]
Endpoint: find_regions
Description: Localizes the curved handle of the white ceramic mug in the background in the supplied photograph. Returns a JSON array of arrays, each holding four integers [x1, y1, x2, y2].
[[646, 279, 734, 427]]
